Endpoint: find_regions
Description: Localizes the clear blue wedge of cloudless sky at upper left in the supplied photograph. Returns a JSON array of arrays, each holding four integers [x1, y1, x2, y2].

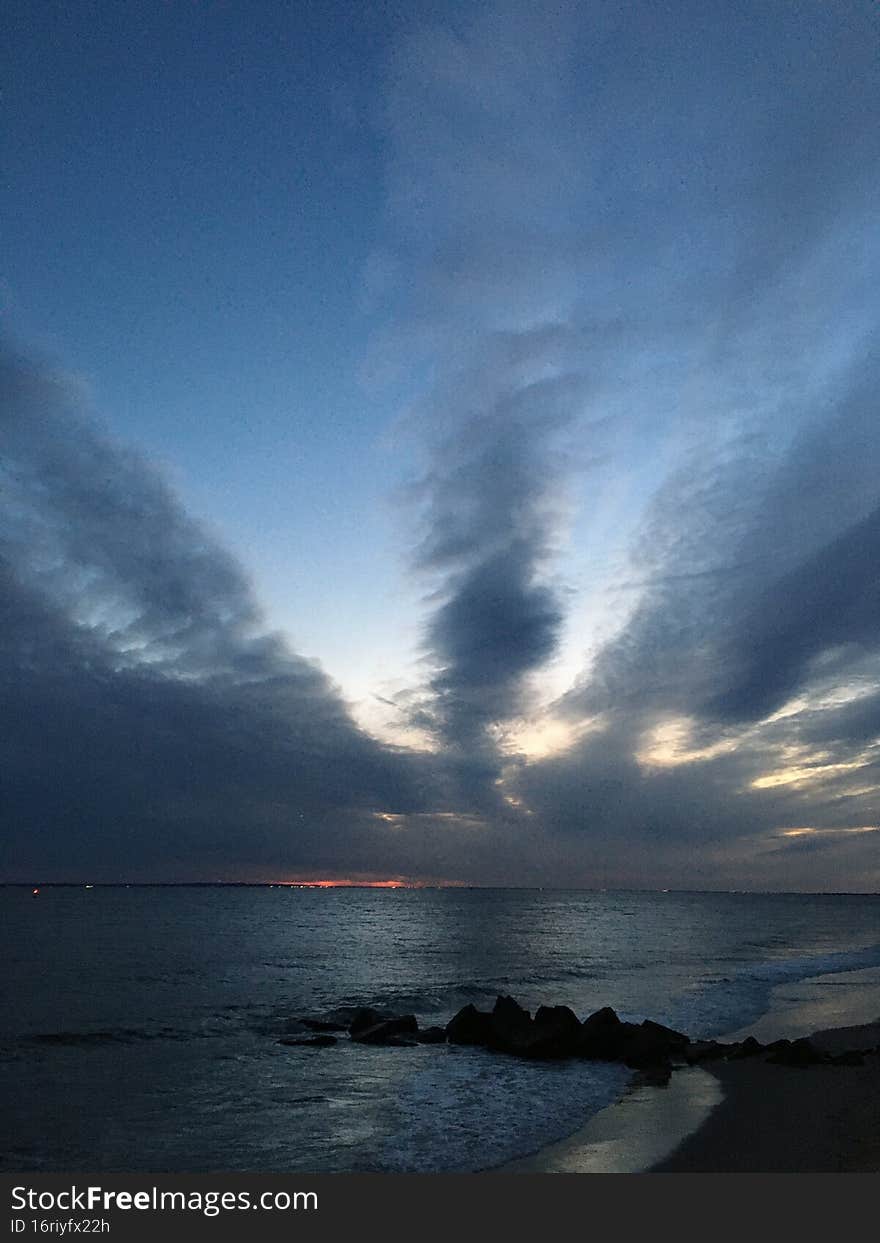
[[4, 4, 425, 701]]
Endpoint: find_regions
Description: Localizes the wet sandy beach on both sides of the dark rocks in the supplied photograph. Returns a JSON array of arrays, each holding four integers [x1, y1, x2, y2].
[[492, 967, 880, 1173]]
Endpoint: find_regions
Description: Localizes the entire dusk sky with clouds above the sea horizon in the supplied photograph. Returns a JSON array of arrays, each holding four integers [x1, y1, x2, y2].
[[0, 0, 880, 891]]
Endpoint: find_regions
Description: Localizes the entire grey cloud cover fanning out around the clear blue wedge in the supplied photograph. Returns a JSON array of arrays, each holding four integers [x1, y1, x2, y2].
[[6, 2, 880, 888]]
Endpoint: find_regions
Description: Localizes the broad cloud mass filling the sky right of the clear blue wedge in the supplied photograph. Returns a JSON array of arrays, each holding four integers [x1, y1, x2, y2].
[[350, 4, 880, 884]]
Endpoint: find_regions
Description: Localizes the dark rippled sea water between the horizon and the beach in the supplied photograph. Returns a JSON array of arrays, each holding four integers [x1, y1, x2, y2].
[[0, 888, 880, 1171]]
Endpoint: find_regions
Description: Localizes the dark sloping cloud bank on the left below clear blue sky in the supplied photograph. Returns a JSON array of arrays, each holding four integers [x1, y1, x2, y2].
[[0, 349, 431, 879]]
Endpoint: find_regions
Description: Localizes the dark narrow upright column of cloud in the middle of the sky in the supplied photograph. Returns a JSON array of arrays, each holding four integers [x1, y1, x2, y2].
[[414, 327, 583, 750]]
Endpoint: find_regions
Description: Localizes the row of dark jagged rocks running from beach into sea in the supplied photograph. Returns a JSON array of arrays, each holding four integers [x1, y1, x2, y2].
[[280, 997, 875, 1075]]
